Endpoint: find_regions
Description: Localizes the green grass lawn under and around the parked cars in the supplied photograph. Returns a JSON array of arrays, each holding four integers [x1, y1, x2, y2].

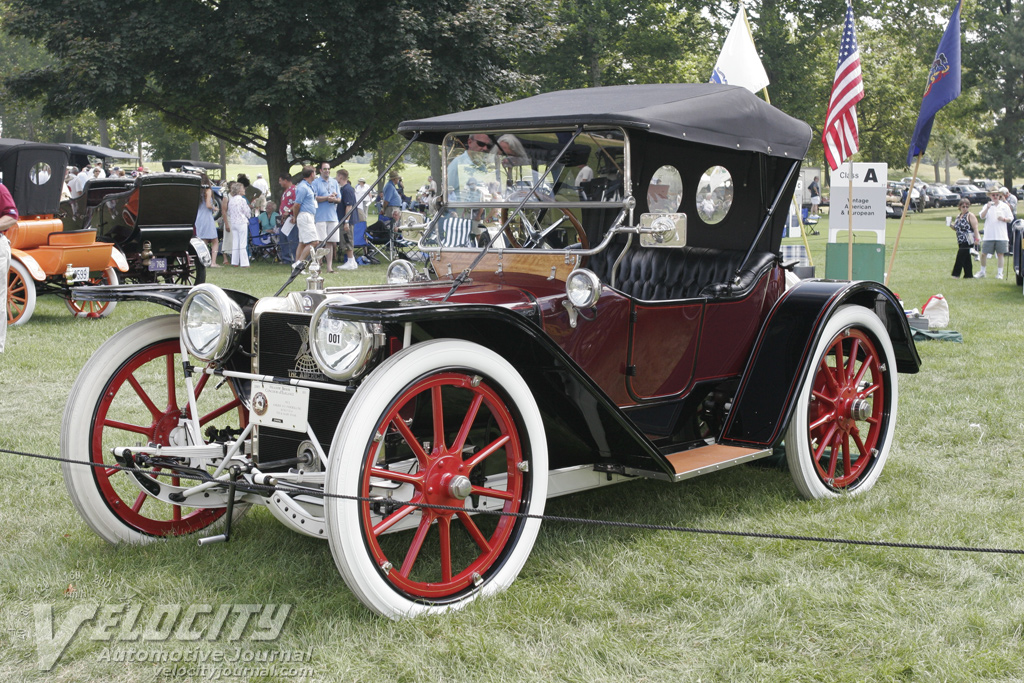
[[0, 210, 1024, 683]]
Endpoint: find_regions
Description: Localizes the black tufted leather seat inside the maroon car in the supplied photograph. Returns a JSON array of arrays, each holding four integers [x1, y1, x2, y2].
[[590, 244, 775, 301]]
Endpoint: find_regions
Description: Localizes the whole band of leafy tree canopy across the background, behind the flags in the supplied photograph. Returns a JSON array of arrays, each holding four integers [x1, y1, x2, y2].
[[0, 0, 1003, 187]]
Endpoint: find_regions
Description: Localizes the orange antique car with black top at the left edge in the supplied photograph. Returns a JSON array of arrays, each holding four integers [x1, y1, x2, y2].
[[0, 138, 128, 325]]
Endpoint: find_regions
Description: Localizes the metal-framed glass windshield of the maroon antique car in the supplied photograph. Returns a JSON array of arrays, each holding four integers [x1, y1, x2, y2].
[[441, 130, 628, 249]]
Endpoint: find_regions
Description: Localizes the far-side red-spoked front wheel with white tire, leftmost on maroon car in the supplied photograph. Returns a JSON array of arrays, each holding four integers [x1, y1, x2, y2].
[[60, 315, 248, 543]]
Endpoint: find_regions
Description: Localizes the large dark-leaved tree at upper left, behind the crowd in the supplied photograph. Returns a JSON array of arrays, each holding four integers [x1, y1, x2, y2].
[[5, 0, 544, 200]]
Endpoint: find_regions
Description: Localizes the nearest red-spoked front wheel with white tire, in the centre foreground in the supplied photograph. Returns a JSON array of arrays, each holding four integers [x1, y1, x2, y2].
[[327, 340, 547, 617]]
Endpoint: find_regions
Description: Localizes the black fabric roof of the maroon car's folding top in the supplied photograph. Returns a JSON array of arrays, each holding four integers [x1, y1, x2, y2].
[[398, 83, 811, 160]]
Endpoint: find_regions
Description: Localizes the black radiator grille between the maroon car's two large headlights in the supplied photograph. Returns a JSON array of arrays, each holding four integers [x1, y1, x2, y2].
[[253, 311, 350, 471]]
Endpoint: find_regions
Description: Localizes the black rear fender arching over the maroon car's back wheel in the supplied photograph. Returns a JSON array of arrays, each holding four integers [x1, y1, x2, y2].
[[721, 281, 921, 447]]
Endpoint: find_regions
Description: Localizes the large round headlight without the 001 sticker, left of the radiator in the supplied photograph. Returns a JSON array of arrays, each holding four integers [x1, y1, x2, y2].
[[181, 285, 246, 361]]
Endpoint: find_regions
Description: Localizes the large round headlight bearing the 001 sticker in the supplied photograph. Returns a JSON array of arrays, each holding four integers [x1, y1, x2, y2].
[[309, 299, 379, 381]]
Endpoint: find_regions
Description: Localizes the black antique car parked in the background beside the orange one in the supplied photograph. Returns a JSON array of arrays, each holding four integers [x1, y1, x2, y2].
[[60, 173, 210, 285]]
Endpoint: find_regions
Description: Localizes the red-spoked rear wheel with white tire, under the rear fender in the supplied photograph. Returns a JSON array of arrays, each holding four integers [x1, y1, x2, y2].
[[785, 306, 897, 499]]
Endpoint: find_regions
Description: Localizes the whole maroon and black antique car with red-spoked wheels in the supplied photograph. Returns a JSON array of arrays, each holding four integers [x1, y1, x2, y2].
[[60, 84, 921, 618]]
